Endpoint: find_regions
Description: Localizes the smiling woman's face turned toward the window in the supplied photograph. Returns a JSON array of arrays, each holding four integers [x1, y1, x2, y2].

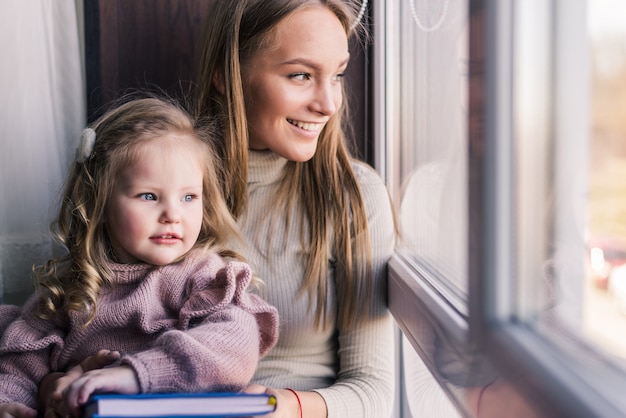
[[242, 6, 349, 161]]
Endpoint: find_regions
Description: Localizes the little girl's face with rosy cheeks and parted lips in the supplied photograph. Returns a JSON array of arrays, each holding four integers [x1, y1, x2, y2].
[[107, 133, 203, 266]]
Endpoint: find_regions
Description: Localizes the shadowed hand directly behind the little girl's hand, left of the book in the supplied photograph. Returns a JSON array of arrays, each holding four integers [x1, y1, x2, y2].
[[39, 350, 120, 418]]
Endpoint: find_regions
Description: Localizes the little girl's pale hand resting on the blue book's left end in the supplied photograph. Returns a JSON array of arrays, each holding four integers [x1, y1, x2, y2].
[[63, 366, 140, 416]]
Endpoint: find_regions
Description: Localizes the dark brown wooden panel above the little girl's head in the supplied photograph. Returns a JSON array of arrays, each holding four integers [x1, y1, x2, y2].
[[85, 0, 215, 118]]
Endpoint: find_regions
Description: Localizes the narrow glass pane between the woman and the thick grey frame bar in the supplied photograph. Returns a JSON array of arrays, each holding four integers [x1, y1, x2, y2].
[[392, 0, 470, 312]]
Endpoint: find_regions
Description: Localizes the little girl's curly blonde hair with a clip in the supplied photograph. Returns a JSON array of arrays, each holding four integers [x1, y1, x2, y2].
[[35, 97, 240, 325]]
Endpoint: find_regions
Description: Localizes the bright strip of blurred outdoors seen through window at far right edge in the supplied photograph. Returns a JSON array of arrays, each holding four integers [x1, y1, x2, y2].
[[583, 0, 626, 359]]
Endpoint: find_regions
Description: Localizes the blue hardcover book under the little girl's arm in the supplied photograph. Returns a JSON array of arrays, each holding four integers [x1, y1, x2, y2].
[[83, 392, 276, 418]]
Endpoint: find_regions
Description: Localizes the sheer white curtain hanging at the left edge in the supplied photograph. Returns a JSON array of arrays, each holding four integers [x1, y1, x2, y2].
[[0, 0, 86, 303]]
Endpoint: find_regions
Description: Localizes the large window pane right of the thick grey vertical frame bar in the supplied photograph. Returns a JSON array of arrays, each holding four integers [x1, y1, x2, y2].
[[513, 0, 626, 366]]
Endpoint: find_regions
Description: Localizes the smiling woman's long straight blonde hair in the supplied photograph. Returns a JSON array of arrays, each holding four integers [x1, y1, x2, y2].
[[195, 0, 372, 327]]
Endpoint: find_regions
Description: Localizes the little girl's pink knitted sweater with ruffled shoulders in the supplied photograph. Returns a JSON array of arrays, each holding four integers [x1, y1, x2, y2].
[[0, 248, 278, 408]]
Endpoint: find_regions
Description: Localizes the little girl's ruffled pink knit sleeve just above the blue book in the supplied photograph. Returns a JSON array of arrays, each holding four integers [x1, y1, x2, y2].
[[122, 262, 278, 392]]
